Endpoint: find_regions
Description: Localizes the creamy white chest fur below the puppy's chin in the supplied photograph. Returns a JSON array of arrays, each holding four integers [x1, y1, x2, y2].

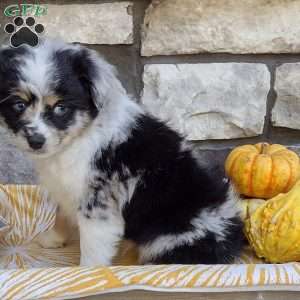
[[36, 126, 99, 224]]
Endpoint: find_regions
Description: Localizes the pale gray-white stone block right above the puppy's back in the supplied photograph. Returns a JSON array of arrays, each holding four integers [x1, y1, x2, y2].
[[142, 63, 270, 140]]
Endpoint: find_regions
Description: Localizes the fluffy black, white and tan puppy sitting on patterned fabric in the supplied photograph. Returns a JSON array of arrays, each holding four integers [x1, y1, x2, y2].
[[0, 40, 242, 266]]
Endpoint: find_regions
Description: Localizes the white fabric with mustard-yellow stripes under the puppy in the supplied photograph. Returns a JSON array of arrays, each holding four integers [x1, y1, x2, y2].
[[0, 185, 300, 300]]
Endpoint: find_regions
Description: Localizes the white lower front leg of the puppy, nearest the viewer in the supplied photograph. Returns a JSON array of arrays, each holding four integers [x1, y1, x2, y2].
[[78, 211, 124, 267]]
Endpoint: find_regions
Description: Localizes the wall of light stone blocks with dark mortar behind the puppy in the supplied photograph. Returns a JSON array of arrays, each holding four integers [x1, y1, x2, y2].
[[0, 0, 300, 181]]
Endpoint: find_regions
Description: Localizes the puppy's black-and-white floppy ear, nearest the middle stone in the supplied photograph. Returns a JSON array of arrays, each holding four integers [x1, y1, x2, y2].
[[74, 48, 126, 111]]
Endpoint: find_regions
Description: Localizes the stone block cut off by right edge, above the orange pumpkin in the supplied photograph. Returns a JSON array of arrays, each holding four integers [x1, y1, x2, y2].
[[272, 63, 300, 129]]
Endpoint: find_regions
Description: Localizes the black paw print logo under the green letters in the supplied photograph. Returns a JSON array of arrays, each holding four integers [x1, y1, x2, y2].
[[4, 17, 45, 48]]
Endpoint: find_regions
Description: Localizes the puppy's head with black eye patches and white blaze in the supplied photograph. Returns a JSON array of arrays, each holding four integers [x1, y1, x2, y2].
[[0, 40, 122, 156]]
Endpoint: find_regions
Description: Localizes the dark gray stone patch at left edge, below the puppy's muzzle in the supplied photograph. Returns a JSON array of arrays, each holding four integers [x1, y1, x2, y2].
[[0, 130, 36, 184]]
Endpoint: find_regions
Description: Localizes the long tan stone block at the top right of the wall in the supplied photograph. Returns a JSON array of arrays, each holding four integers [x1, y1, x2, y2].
[[142, 0, 300, 56]]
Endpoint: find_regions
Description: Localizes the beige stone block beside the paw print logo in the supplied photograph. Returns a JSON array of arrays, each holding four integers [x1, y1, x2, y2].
[[37, 2, 133, 45]]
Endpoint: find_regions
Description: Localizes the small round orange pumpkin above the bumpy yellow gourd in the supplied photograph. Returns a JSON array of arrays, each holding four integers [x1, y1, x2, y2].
[[225, 143, 300, 199]]
